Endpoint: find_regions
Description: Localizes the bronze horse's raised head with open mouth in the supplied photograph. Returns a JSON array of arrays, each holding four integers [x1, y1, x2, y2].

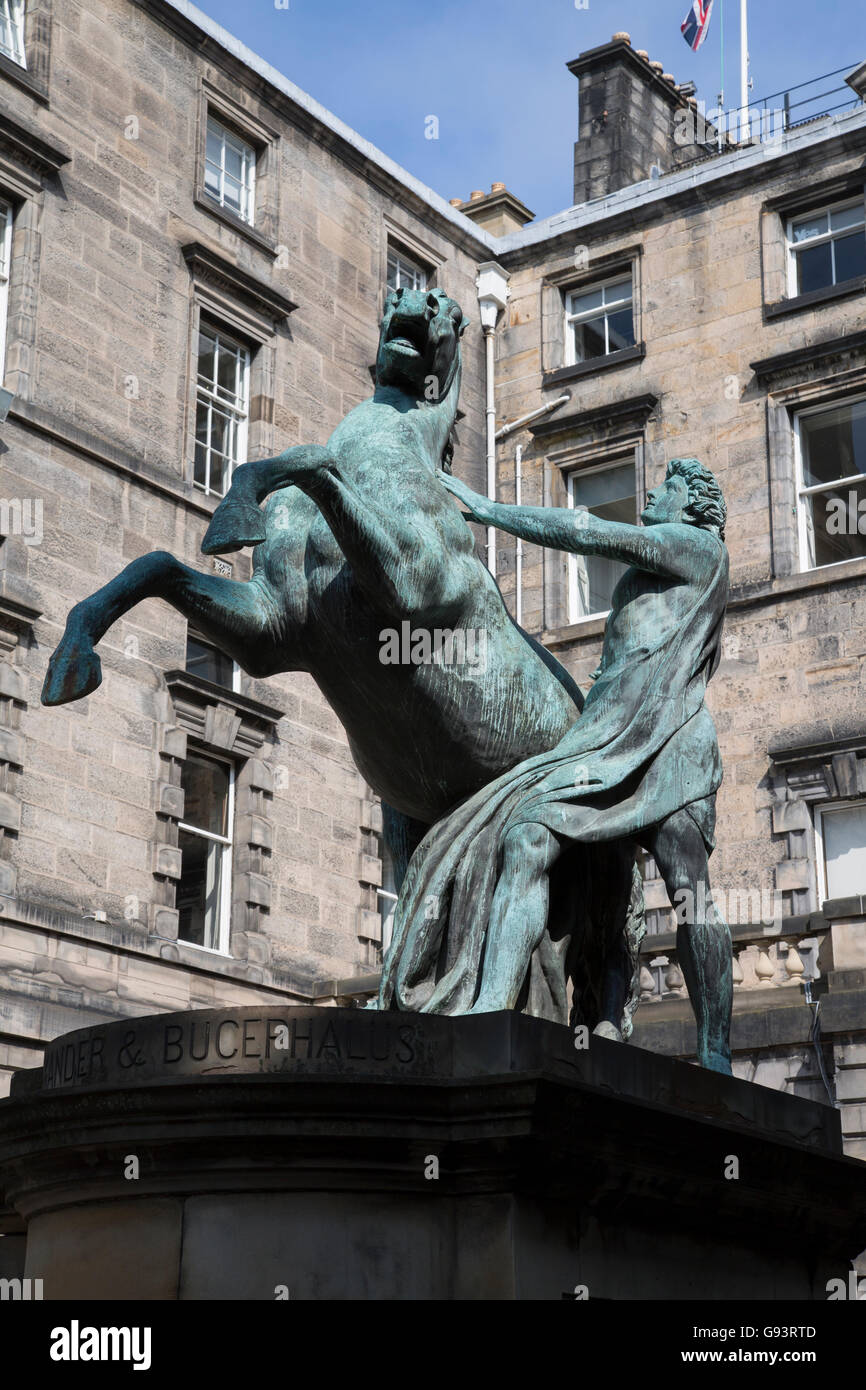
[[375, 289, 468, 402]]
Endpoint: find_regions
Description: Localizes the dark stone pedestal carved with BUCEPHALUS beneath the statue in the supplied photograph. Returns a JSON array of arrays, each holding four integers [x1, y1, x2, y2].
[[0, 1008, 866, 1301]]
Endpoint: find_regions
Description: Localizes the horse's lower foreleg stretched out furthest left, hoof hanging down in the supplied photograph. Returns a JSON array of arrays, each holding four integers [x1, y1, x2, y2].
[[42, 550, 281, 705]]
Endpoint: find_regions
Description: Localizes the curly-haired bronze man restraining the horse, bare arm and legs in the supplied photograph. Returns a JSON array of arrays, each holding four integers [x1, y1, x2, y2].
[[441, 459, 733, 1073]]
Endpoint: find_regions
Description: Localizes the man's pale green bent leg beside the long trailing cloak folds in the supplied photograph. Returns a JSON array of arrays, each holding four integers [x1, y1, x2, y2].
[[468, 824, 560, 1013]]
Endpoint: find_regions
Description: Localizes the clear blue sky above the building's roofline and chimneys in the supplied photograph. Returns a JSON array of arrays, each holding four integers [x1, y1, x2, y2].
[[199, 0, 866, 217]]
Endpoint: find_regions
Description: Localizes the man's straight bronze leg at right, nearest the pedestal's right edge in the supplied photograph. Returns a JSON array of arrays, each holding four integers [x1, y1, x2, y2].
[[646, 810, 734, 1076]]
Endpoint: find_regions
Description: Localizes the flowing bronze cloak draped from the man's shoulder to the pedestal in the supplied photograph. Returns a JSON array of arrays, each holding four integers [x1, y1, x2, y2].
[[378, 525, 728, 1037]]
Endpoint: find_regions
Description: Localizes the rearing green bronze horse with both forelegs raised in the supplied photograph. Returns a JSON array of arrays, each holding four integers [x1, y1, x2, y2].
[[42, 289, 644, 1026]]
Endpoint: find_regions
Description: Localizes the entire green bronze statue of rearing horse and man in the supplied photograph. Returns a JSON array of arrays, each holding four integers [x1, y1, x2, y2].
[[43, 291, 730, 1070]]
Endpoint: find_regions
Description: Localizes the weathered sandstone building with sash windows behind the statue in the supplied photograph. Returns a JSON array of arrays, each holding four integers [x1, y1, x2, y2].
[[0, 0, 866, 1158]]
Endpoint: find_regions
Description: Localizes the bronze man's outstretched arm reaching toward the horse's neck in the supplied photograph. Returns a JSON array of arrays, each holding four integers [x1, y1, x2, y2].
[[439, 473, 706, 580]]
